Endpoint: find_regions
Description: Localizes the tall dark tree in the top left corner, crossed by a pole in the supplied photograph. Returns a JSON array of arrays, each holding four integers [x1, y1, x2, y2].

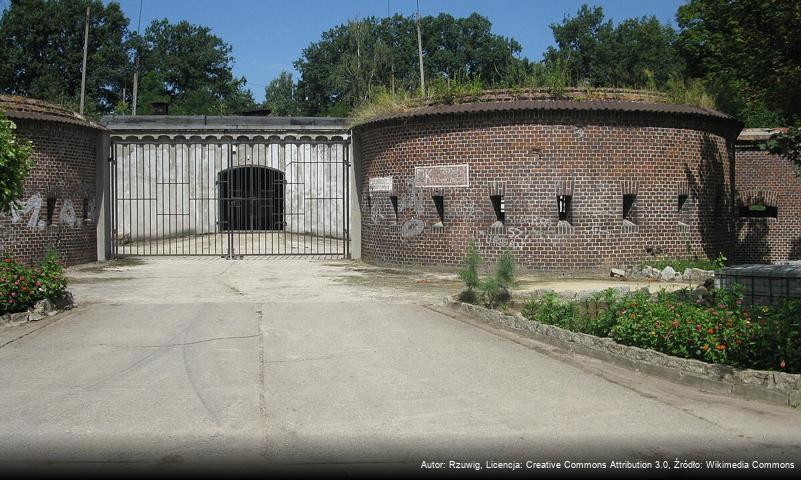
[[0, 0, 130, 113]]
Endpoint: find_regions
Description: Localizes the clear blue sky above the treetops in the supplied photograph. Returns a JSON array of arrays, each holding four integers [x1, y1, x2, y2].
[[111, 0, 684, 101]]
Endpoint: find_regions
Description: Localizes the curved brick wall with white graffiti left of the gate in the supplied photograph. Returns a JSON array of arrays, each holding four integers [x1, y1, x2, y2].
[[0, 114, 101, 264]]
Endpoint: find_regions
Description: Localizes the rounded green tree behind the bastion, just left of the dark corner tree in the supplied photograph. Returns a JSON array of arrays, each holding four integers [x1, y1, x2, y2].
[[544, 5, 684, 87]]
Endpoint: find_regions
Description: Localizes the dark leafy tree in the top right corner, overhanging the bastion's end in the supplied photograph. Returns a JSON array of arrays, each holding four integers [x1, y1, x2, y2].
[[676, 0, 801, 126]]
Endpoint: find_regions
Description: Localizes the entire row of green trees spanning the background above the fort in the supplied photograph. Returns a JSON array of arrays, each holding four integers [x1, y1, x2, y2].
[[0, 0, 801, 126]]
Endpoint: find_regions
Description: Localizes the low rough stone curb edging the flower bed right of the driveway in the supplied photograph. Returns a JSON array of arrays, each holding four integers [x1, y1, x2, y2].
[[431, 297, 801, 408]]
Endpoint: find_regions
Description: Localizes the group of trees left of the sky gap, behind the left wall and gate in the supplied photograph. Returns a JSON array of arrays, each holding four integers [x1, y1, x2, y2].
[[0, 0, 254, 116]]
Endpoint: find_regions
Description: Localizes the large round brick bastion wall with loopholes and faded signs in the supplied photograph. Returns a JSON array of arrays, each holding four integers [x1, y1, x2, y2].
[[356, 111, 737, 272]]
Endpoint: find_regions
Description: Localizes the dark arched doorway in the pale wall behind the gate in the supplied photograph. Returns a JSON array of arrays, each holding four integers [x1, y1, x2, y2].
[[217, 166, 286, 231]]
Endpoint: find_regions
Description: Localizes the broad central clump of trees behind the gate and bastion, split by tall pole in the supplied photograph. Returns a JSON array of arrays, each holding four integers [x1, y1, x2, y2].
[[294, 13, 528, 115]]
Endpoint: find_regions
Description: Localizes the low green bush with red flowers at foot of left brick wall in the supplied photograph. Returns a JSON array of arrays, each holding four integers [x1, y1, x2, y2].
[[0, 252, 67, 315]]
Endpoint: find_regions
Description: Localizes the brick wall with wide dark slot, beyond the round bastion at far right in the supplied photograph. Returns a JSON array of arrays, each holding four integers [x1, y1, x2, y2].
[[736, 142, 801, 263]]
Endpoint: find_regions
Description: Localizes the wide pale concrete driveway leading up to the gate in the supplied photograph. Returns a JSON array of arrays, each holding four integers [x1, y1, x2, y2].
[[0, 258, 801, 471]]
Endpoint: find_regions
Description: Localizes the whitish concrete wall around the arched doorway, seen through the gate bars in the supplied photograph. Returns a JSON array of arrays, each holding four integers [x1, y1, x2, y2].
[[112, 143, 348, 241]]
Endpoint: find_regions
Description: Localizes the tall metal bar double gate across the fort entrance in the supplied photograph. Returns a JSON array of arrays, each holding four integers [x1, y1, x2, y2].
[[110, 139, 350, 258]]
